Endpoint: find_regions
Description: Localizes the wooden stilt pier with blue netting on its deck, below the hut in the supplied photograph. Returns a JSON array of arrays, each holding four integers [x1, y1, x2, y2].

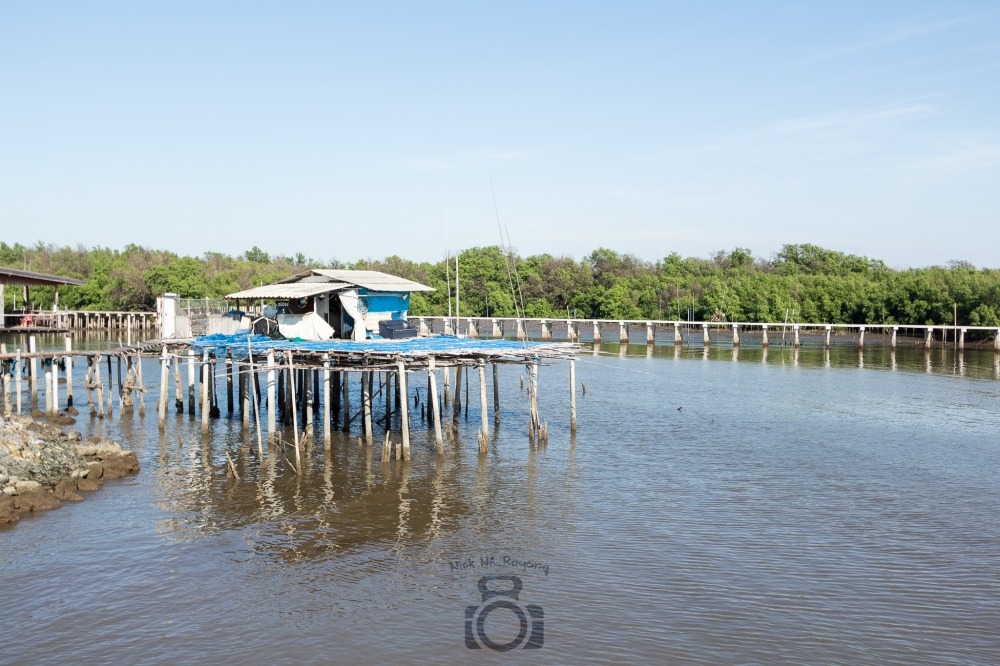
[[0, 334, 578, 470]]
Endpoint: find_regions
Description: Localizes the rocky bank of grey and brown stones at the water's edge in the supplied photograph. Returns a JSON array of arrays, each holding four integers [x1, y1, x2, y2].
[[0, 416, 139, 526]]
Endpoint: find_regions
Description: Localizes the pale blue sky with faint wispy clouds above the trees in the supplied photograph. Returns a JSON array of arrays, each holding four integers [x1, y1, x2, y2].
[[0, 0, 1000, 267]]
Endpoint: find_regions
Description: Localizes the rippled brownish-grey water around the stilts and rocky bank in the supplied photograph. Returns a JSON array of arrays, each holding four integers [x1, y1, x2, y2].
[[0, 338, 1000, 664]]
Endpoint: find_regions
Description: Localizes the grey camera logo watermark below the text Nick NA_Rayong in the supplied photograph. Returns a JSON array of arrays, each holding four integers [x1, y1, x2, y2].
[[465, 576, 545, 652]]
